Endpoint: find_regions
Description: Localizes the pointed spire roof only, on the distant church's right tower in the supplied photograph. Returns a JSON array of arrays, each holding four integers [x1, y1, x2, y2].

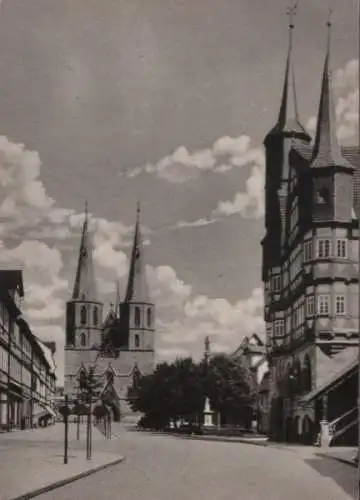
[[125, 202, 150, 303]]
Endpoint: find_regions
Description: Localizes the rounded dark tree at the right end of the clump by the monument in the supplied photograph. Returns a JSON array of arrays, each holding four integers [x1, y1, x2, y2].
[[205, 355, 256, 427]]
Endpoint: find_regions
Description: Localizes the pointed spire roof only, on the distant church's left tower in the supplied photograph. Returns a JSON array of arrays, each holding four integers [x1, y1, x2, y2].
[[72, 202, 97, 302]]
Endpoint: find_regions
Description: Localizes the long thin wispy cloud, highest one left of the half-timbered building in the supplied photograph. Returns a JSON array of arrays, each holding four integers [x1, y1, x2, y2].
[[119, 135, 262, 183]]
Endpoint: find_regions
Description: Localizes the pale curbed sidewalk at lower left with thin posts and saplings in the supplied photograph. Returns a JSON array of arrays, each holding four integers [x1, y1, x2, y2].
[[0, 423, 123, 500]]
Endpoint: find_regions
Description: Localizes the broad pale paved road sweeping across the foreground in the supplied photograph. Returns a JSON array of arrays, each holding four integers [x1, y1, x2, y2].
[[38, 430, 355, 500]]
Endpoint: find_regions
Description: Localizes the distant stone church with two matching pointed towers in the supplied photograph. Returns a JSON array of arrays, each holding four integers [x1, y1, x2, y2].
[[64, 203, 155, 420]]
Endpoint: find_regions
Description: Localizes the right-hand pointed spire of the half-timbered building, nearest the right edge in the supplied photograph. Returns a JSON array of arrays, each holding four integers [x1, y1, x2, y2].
[[311, 10, 353, 169]]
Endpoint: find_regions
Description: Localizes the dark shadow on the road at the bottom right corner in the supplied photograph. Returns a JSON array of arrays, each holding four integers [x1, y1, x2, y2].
[[304, 455, 358, 499]]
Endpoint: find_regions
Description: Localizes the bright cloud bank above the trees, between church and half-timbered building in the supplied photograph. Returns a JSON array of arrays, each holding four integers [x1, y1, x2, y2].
[[143, 266, 264, 355]]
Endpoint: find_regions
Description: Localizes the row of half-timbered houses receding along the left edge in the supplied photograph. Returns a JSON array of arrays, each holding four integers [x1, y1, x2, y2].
[[0, 270, 56, 432]]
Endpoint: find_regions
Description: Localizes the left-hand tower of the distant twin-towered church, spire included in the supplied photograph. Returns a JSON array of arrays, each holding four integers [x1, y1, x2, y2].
[[65, 206, 103, 393]]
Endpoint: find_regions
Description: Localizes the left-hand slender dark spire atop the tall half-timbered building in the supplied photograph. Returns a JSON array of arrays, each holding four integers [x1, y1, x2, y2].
[[270, 2, 310, 141]]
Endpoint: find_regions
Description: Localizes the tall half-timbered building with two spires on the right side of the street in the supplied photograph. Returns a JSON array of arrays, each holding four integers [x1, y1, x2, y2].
[[262, 18, 360, 443]]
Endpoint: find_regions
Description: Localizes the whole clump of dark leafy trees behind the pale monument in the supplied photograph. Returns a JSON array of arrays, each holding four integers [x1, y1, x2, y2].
[[128, 355, 256, 428]]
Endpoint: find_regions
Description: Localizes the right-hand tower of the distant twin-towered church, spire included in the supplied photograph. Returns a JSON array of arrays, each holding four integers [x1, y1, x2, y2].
[[120, 204, 155, 356]]
